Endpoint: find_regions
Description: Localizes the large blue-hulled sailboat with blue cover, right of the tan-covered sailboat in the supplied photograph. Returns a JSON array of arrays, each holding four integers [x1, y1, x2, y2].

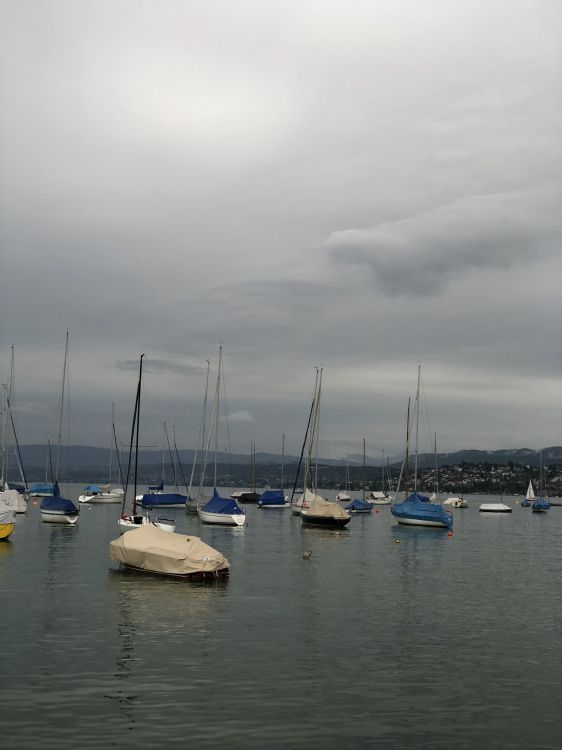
[[390, 365, 453, 529]]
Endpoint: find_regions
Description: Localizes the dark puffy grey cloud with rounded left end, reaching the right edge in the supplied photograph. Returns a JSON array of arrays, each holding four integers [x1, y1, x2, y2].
[[328, 183, 562, 296]]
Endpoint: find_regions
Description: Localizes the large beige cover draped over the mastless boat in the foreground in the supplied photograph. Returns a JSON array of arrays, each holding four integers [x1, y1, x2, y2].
[[109, 523, 230, 576]]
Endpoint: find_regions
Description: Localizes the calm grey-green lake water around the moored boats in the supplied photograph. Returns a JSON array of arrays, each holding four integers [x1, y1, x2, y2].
[[0, 485, 562, 750]]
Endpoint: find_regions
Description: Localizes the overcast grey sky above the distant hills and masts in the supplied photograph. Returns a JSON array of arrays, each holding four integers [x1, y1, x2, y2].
[[0, 0, 562, 458]]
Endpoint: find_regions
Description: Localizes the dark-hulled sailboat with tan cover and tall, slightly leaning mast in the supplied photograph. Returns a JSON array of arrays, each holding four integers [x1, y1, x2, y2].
[[300, 368, 351, 529]]
